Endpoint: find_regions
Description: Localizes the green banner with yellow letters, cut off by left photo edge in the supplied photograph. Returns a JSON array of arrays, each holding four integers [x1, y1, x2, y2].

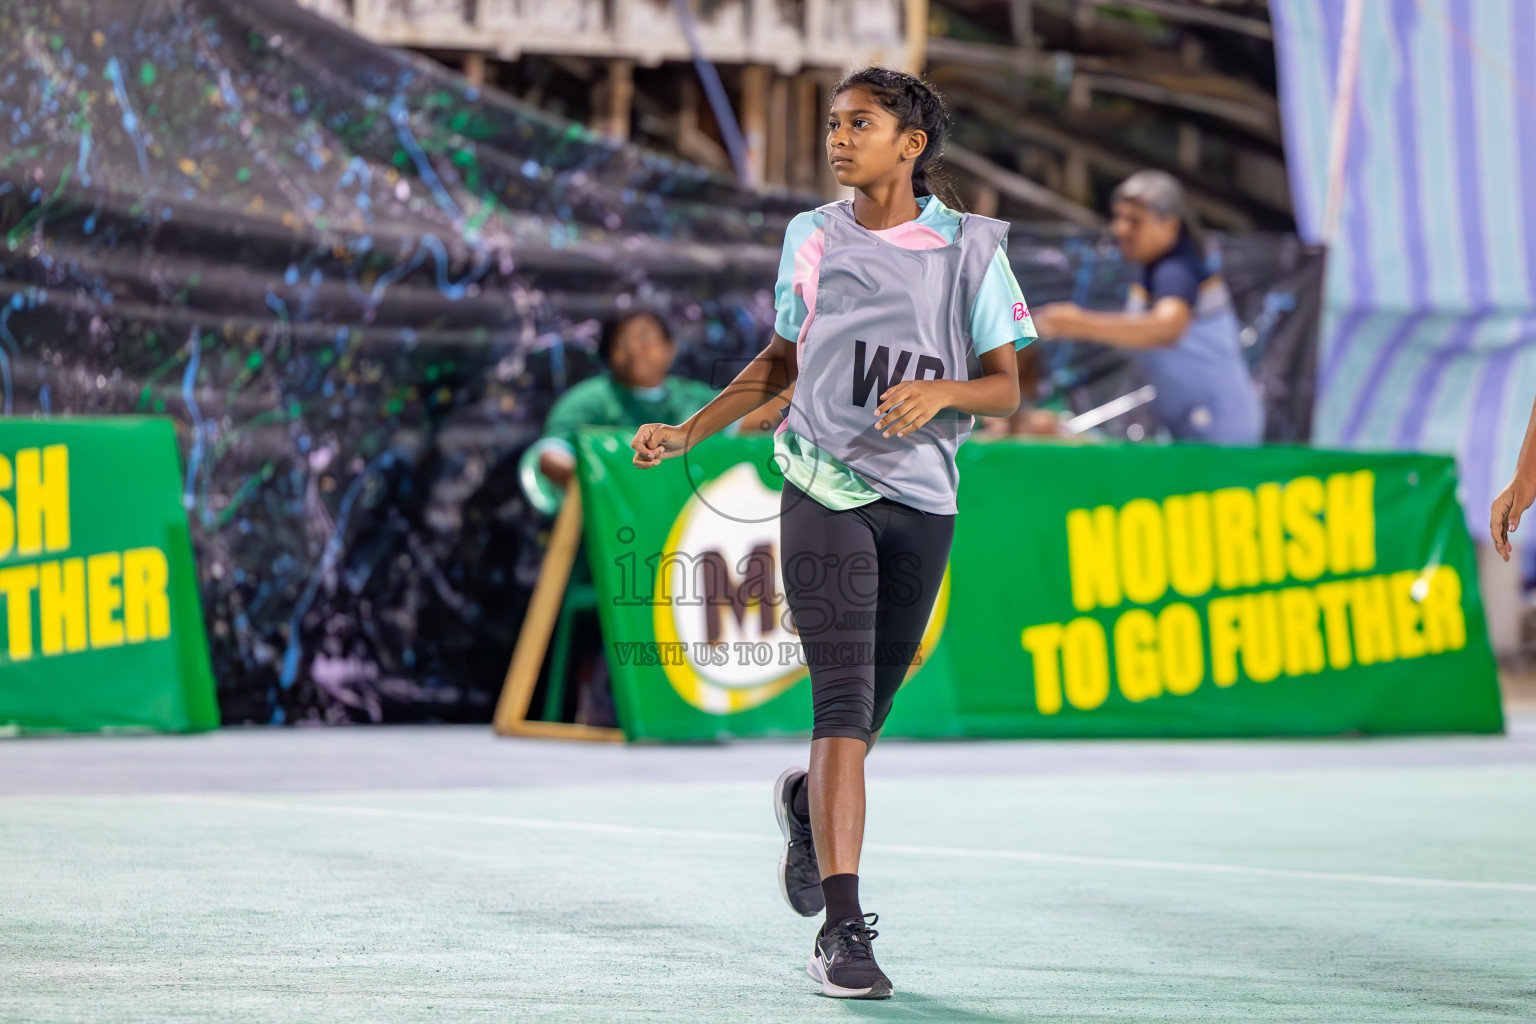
[[0, 418, 218, 732]]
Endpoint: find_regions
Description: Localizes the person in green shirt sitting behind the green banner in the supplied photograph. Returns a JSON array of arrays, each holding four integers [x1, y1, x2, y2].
[[535, 307, 777, 490]]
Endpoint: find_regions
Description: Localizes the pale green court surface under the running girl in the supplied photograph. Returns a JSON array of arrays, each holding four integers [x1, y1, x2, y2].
[[0, 731, 1536, 1024]]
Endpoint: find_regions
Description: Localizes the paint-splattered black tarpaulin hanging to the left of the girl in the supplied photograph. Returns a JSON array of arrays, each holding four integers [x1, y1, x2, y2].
[[0, 0, 800, 722]]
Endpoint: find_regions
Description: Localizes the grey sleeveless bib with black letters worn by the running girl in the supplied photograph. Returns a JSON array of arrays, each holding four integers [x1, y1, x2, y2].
[[785, 200, 1008, 514]]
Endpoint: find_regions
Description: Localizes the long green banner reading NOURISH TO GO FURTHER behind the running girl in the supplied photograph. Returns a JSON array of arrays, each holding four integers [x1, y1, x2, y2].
[[578, 430, 1504, 740]]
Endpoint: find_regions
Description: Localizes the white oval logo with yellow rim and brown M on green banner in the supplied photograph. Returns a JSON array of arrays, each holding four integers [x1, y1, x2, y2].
[[653, 462, 949, 715]]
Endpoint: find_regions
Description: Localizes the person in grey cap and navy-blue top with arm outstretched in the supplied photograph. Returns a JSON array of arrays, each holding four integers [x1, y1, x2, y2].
[[1035, 170, 1264, 444]]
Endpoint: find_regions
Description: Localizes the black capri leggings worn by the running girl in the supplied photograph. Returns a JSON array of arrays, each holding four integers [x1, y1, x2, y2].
[[779, 481, 955, 743]]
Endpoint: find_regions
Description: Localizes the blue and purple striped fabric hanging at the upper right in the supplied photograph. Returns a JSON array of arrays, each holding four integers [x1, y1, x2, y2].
[[1270, 0, 1536, 537]]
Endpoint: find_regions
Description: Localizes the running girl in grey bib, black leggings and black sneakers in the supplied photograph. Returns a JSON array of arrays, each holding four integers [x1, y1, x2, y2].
[[631, 68, 1034, 999]]
